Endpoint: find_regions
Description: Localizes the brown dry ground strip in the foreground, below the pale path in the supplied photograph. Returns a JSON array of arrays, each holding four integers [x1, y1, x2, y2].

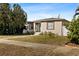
[[0, 44, 79, 56]]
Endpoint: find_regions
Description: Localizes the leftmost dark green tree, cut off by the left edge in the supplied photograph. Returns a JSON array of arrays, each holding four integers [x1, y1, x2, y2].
[[0, 3, 11, 34]]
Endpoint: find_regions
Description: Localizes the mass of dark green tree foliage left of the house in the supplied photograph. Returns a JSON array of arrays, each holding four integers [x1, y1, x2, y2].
[[0, 3, 27, 34]]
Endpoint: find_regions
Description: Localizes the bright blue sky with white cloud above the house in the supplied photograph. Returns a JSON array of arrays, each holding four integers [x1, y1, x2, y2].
[[19, 3, 79, 21]]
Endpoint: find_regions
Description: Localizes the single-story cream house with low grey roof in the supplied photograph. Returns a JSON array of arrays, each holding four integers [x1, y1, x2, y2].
[[23, 18, 69, 36]]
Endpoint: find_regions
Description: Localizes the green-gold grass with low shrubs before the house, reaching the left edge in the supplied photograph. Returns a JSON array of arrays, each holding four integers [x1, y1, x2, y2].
[[0, 33, 70, 45]]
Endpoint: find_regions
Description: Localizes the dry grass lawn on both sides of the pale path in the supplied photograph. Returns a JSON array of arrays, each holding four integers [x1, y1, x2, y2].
[[0, 35, 79, 56]]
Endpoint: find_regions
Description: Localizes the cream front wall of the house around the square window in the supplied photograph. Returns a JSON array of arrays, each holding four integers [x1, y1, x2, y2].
[[41, 21, 62, 35]]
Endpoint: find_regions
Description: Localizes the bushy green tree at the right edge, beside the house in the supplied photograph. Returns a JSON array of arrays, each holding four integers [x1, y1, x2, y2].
[[68, 6, 79, 44]]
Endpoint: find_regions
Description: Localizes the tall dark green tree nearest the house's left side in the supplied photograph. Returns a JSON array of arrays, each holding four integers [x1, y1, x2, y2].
[[13, 4, 27, 34]]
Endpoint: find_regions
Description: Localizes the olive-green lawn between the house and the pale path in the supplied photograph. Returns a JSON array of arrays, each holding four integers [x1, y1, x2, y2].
[[6, 35, 69, 45]]
